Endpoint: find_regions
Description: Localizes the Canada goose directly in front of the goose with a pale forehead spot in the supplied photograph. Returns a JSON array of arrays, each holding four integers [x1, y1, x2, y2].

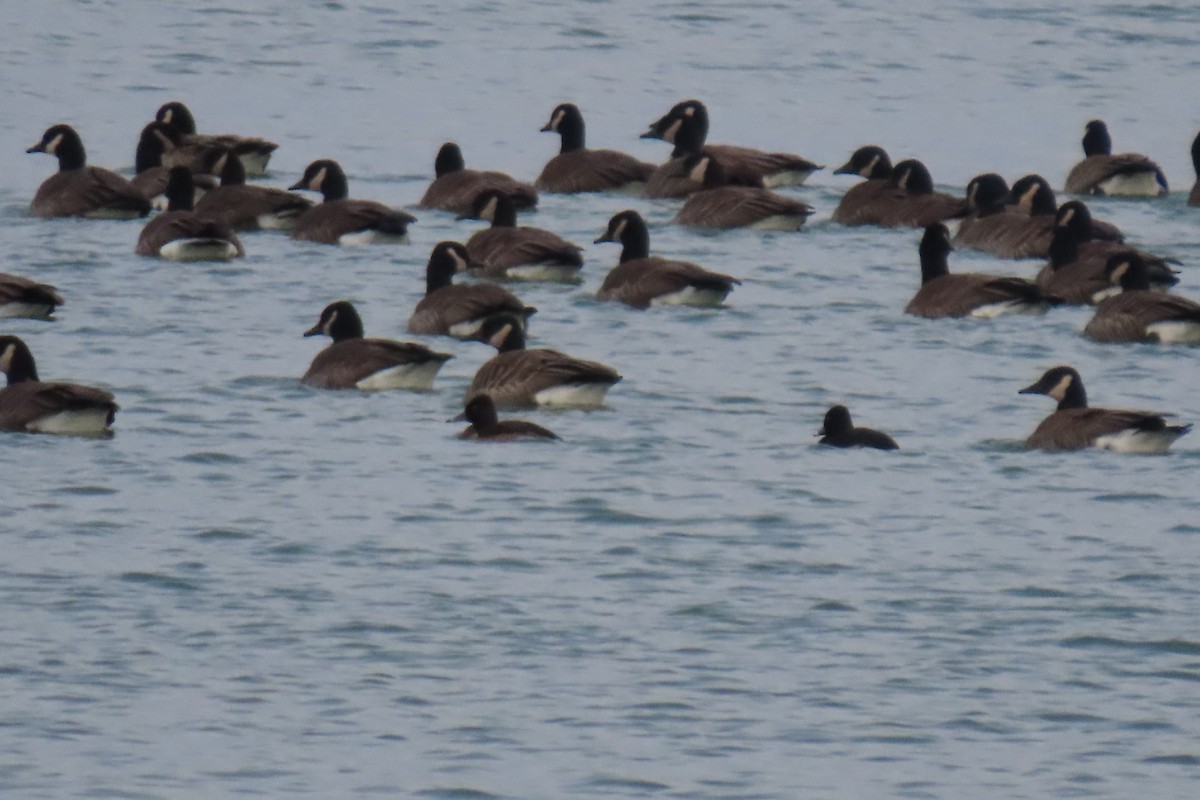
[[674, 152, 812, 230]]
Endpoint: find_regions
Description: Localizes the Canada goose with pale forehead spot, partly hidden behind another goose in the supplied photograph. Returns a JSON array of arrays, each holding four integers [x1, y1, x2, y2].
[[641, 100, 823, 198]]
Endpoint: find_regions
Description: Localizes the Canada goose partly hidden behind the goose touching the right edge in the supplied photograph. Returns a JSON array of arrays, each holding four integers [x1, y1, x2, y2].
[[1037, 200, 1178, 305]]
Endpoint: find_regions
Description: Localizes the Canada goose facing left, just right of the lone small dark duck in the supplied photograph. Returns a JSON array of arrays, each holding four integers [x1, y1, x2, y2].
[[1019, 367, 1192, 453]]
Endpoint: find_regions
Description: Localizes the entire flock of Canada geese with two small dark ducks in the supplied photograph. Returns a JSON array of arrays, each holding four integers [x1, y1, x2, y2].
[[0, 100, 1200, 452]]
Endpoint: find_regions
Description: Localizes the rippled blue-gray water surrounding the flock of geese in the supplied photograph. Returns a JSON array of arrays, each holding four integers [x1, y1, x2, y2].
[[0, 0, 1200, 800]]
